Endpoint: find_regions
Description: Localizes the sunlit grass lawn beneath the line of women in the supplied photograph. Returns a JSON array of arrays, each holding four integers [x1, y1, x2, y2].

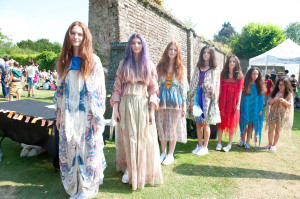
[[0, 86, 300, 199]]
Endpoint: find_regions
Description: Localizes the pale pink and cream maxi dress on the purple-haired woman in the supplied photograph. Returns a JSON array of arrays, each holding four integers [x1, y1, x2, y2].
[[110, 63, 163, 190]]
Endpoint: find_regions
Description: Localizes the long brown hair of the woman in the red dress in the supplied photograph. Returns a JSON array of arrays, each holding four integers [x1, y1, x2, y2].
[[221, 54, 243, 80]]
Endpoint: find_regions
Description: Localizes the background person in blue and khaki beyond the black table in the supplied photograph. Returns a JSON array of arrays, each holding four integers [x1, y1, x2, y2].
[[8, 62, 23, 101]]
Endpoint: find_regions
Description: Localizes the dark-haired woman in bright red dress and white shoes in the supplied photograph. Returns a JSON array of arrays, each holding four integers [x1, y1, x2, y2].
[[216, 55, 244, 152]]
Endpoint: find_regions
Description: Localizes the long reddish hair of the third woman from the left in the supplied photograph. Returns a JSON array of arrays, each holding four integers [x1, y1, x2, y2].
[[157, 41, 183, 79]]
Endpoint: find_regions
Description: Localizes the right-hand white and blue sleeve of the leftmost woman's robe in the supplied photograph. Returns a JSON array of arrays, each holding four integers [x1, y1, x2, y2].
[[86, 55, 106, 128]]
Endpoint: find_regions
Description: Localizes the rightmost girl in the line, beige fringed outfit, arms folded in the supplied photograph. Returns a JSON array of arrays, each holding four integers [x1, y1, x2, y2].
[[265, 77, 294, 151]]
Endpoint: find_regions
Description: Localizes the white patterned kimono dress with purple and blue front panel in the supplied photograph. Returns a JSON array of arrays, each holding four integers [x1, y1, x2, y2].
[[188, 67, 221, 125]]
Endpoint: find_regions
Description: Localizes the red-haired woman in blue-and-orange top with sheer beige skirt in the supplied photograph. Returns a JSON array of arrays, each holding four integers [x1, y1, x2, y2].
[[156, 42, 187, 165]]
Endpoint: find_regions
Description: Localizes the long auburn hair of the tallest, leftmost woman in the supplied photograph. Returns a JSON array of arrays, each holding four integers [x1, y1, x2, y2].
[[57, 21, 93, 79]]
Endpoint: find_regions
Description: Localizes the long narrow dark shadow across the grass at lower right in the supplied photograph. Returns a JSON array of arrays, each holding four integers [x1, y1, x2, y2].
[[173, 164, 300, 180]]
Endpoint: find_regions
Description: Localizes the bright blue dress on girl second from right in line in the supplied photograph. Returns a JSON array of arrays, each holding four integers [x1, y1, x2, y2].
[[239, 84, 264, 145]]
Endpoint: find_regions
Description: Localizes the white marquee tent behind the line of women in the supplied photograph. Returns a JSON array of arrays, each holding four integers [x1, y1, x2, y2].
[[249, 39, 300, 78]]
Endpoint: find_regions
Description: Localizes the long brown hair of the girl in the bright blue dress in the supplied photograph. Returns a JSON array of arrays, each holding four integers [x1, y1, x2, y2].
[[243, 67, 267, 95]]
